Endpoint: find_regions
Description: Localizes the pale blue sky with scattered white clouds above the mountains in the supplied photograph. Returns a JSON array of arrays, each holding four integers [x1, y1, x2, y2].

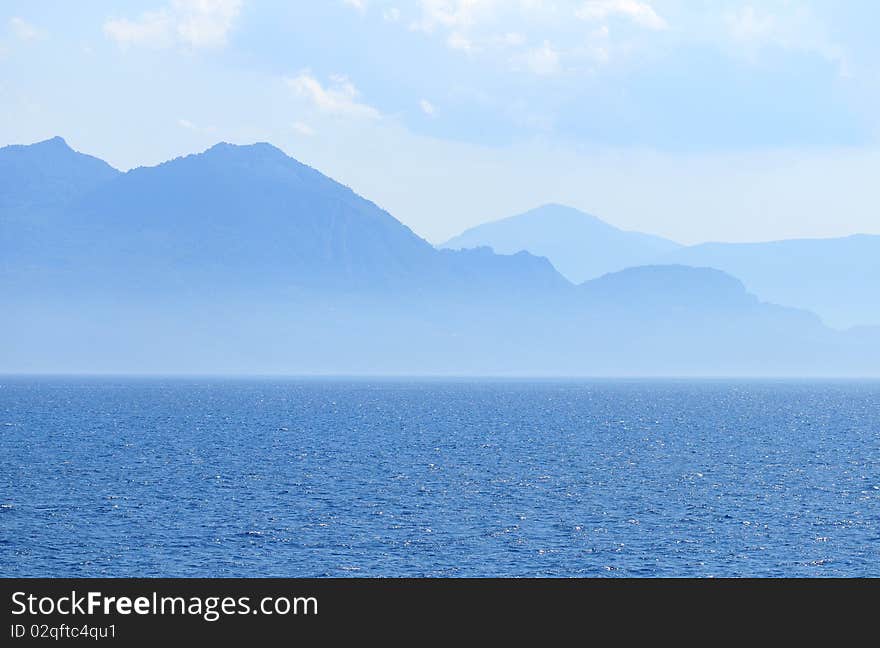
[[0, 0, 880, 243]]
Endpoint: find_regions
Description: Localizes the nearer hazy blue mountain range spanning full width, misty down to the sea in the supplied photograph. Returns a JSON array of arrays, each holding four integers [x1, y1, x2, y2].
[[0, 138, 880, 375]]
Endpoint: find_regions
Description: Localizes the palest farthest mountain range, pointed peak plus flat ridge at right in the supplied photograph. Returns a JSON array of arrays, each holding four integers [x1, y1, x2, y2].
[[441, 205, 880, 329]]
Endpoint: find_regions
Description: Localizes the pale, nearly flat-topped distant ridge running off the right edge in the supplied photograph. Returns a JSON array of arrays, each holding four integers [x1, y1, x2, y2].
[[657, 235, 880, 328]]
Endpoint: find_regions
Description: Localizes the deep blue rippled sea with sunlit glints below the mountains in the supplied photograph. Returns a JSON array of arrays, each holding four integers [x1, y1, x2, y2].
[[0, 377, 880, 576]]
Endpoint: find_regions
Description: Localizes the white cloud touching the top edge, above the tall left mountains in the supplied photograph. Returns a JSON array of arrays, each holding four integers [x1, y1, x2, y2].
[[104, 0, 242, 49]]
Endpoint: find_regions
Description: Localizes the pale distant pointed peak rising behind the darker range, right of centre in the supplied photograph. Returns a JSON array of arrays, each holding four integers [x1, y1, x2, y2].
[[441, 205, 681, 283]]
